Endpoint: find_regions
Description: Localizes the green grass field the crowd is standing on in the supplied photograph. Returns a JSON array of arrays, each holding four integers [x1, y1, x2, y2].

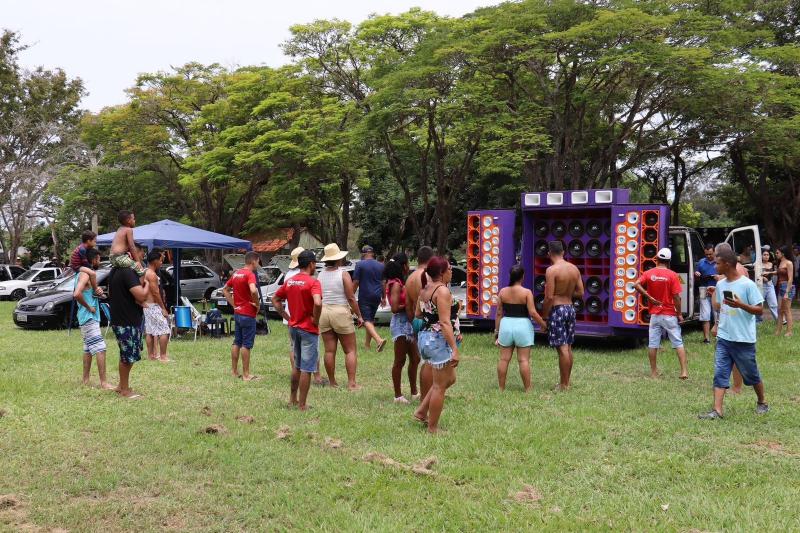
[[0, 303, 800, 531]]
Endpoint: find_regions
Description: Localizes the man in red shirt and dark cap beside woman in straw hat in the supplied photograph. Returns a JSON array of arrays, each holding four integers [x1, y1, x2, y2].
[[272, 250, 322, 411]]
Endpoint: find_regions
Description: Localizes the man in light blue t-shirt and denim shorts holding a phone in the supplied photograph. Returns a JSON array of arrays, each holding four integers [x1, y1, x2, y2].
[[700, 243, 769, 420]]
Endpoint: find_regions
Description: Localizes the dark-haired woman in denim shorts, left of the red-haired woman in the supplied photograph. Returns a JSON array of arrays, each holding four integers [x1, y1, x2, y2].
[[383, 253, 419, 403]]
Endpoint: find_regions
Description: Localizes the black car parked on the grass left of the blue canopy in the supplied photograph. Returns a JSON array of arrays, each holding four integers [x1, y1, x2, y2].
[[13, 269, 111, 329]]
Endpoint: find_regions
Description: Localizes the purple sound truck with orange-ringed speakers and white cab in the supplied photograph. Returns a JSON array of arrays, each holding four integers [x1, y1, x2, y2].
[[466, 189, 762, 337]]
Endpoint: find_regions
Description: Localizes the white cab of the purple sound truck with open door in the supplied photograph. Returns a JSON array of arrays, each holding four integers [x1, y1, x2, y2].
[[669, 222, 764, 320]]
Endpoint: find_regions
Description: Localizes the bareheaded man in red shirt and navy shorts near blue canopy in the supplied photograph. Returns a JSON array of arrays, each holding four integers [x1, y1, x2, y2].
[[222, 252, 261, 381]]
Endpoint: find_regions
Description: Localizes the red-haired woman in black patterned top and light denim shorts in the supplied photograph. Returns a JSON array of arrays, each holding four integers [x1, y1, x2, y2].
[[414, 256, 461, 433]]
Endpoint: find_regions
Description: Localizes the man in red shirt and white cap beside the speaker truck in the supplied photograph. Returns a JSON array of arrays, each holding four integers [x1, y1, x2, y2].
[[635, 248, 689, 379]]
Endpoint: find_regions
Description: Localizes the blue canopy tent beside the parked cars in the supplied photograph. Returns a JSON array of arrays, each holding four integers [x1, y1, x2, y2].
[[97, 219, 253, 308]]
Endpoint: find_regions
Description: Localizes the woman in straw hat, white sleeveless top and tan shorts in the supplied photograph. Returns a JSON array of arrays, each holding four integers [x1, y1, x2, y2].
[[317, 244, 364, 390]]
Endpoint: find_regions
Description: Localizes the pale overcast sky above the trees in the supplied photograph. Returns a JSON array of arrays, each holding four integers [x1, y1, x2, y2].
[[0, 0, 497, 112]]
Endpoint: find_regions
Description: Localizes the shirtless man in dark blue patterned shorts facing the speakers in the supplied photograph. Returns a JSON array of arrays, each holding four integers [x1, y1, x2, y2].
[[542, 241, 583, 390]]
